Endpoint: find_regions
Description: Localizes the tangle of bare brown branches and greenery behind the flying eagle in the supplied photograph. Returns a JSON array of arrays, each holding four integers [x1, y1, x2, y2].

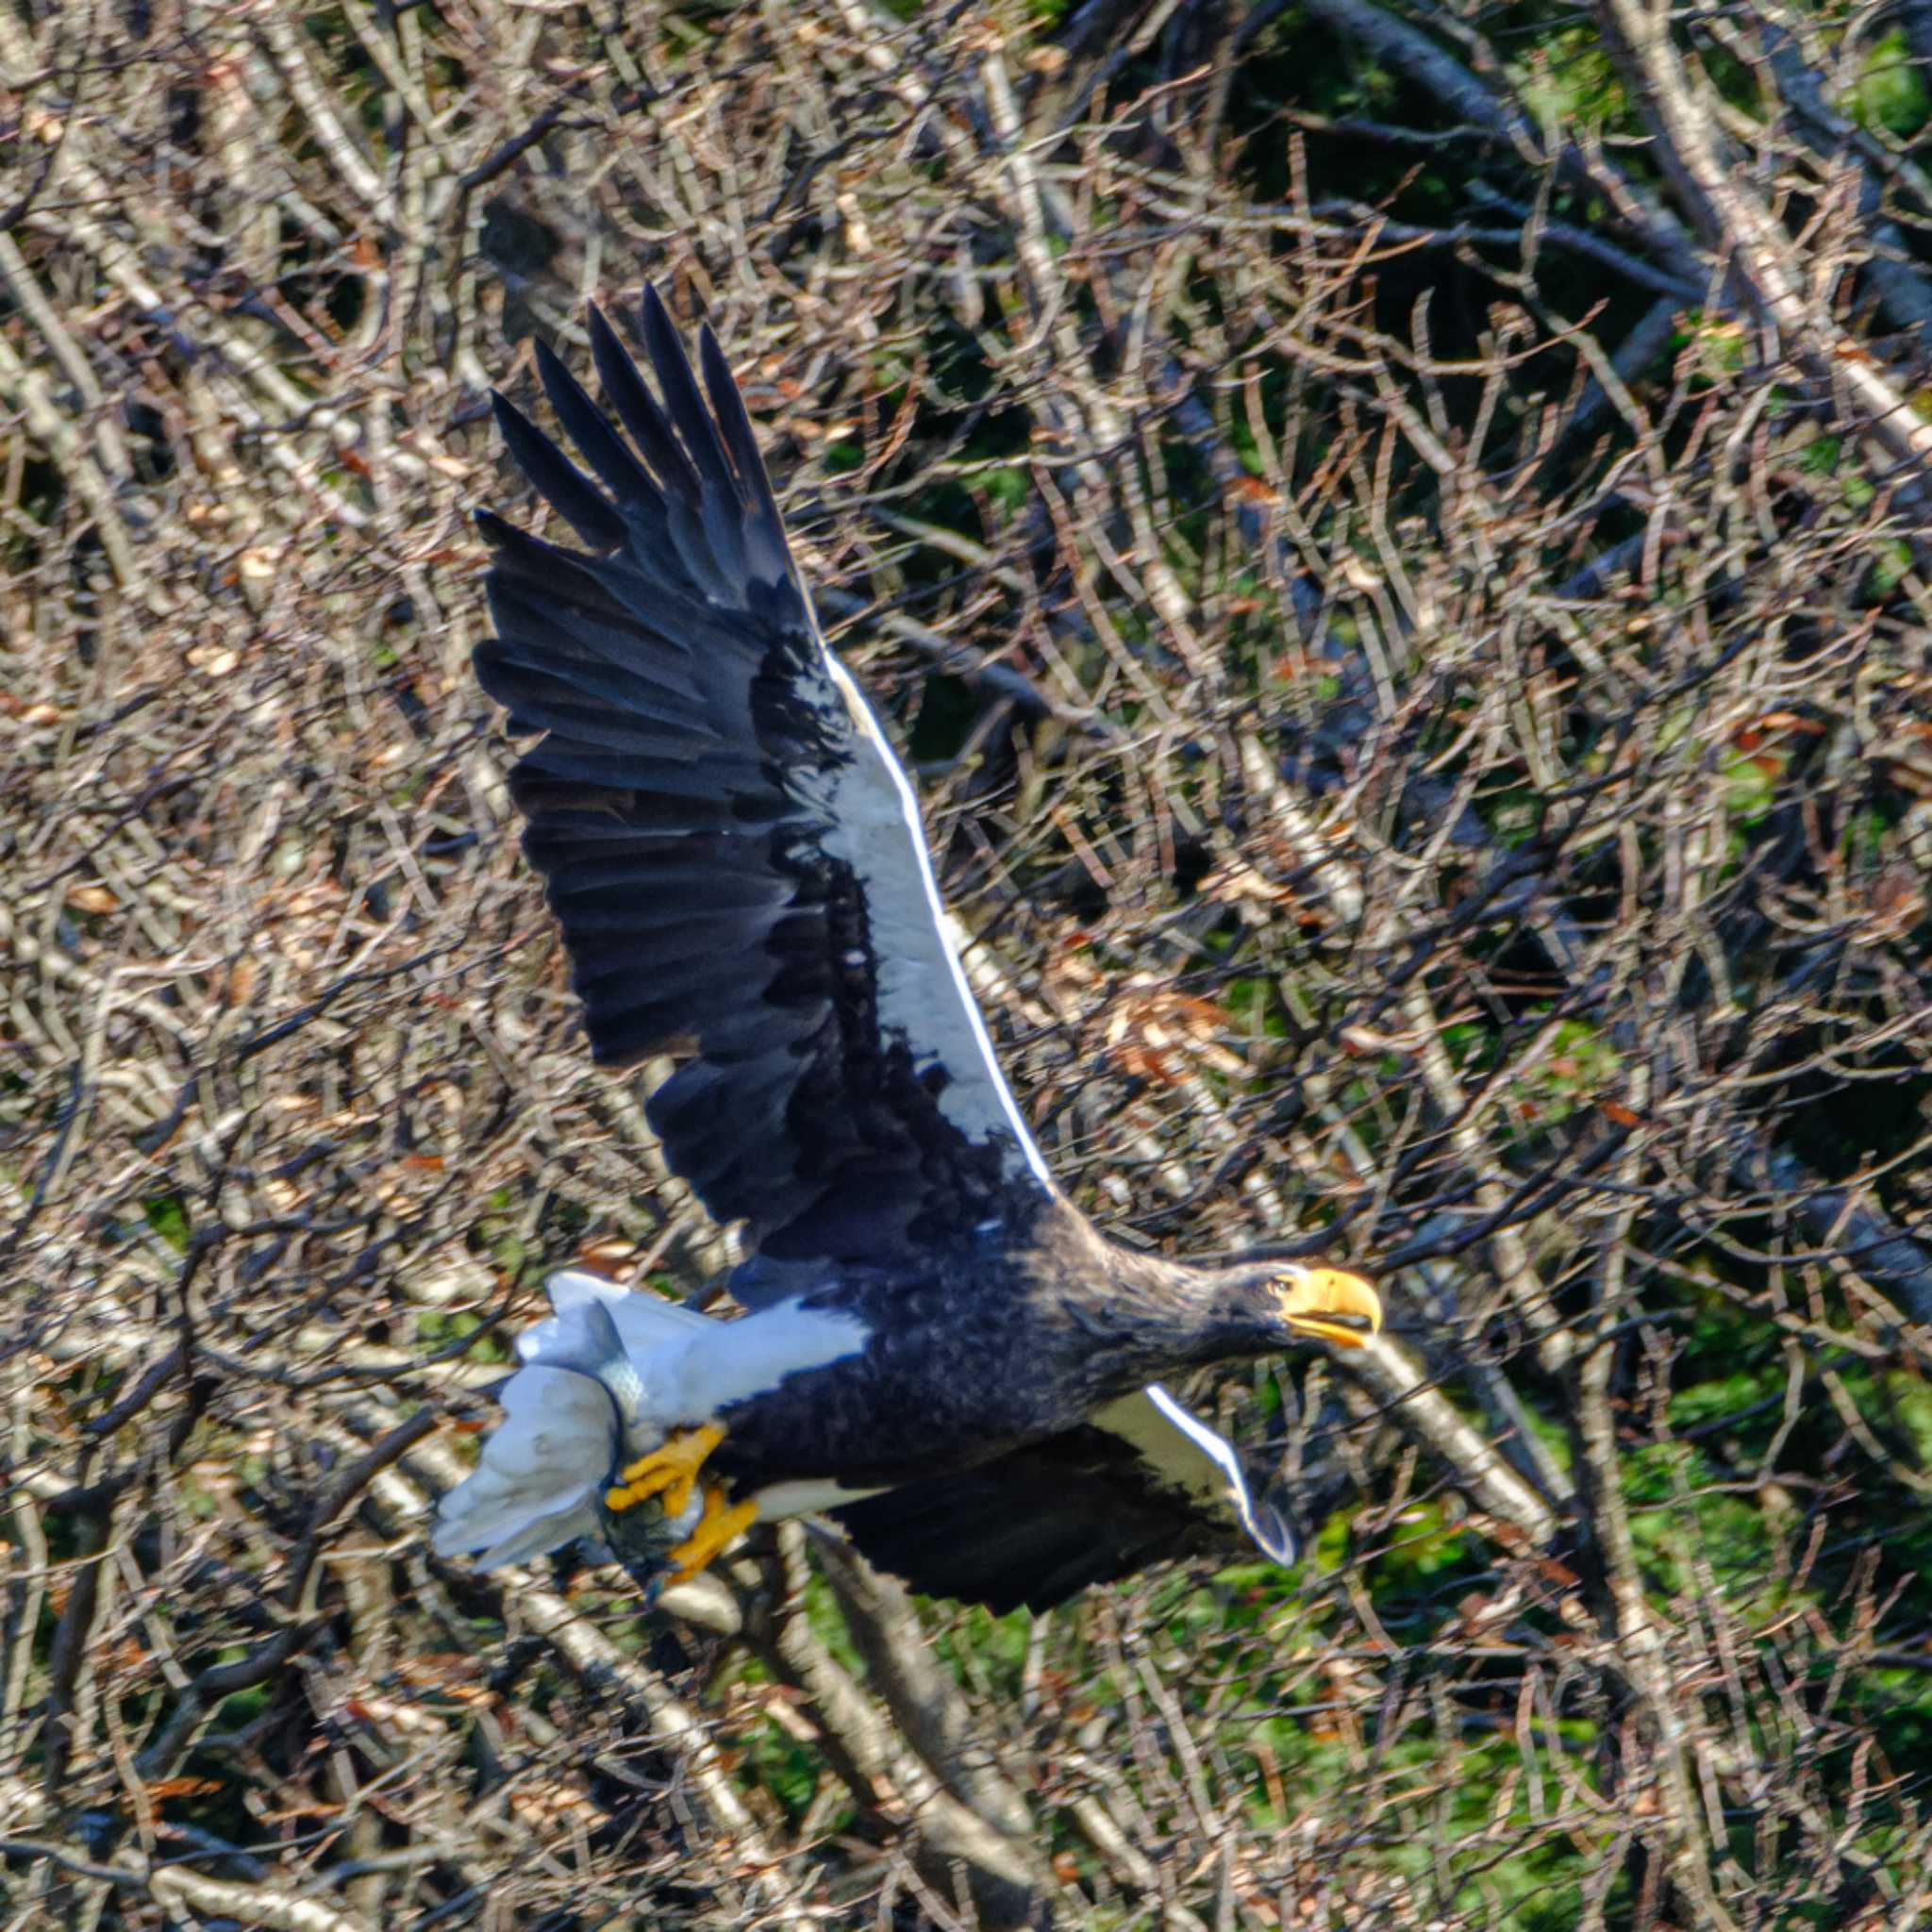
[[0, 0, 1932, 1932]]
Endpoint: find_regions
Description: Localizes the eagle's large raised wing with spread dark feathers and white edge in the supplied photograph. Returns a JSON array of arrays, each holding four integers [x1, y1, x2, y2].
[[475, 290, 1051, 1261]]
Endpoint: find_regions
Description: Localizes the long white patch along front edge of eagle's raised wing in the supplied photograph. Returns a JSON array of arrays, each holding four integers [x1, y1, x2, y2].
[[787, 625, 1053, 1186]]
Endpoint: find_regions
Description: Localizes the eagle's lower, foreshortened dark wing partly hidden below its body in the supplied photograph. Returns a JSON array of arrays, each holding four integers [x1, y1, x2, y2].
[[833, 1387, 1294, 1613]]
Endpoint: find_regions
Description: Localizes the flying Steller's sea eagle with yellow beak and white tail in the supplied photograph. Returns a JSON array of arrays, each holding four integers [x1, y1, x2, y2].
[[437, 288, 1381, 1609]]
